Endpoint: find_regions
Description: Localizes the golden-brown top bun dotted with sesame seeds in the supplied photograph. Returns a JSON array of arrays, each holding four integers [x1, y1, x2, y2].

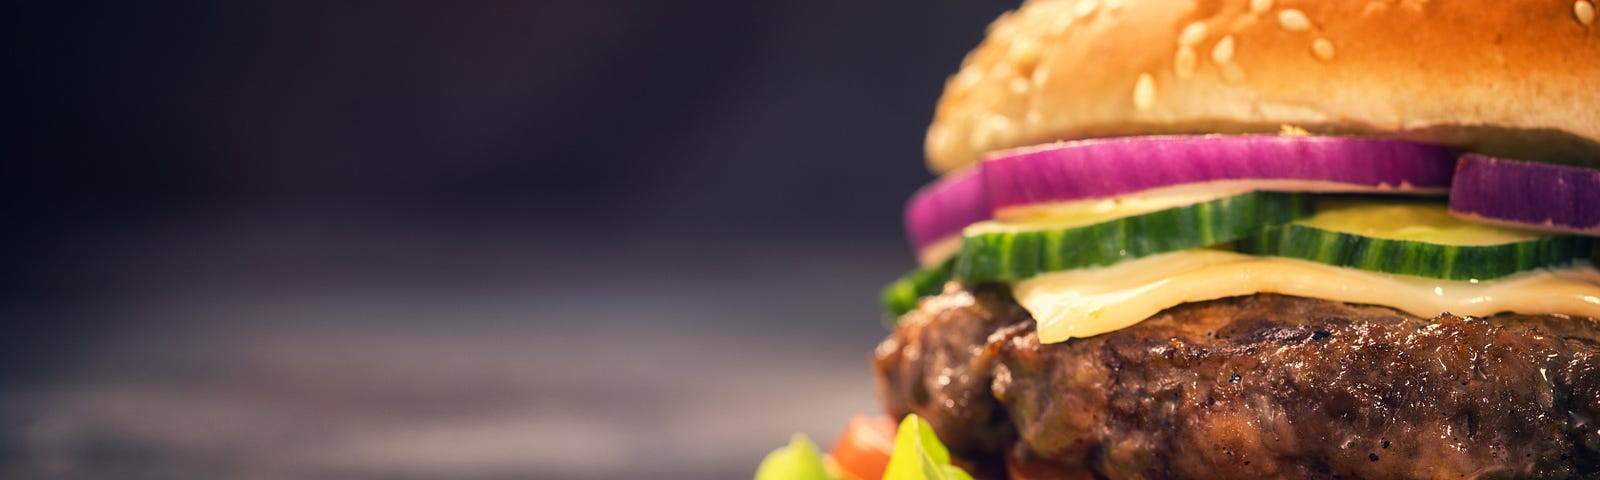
[[926, 0, 1600, 171]]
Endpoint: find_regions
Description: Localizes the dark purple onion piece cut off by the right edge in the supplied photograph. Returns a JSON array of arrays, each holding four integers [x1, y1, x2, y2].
[[1450, 154, 1600, 235]]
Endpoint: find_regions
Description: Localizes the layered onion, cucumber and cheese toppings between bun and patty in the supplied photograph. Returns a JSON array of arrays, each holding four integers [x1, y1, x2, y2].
[[885, 134, 1600, 342]]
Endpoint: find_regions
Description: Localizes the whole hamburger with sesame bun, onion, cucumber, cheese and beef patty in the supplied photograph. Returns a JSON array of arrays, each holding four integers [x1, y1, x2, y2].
[[758, 0, 1600, 478]]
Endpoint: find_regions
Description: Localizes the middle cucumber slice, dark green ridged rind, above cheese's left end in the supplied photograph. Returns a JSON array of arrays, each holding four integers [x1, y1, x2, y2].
[[952, 192, 1310, 282]]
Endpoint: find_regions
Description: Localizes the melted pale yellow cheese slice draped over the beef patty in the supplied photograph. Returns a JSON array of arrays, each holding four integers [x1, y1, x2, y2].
[[1011, 250, 1600, 344]]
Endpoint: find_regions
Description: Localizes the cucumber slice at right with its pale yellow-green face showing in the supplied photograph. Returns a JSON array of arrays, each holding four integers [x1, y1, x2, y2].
[[1238, 200, 1594, 280]]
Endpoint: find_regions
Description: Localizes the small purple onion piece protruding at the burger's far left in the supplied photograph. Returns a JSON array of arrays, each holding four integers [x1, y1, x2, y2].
[[906, 168, 994, 262]]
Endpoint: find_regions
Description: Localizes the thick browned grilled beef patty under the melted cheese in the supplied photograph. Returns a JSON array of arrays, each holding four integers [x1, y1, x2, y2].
[[875, 285, 1600, 478]]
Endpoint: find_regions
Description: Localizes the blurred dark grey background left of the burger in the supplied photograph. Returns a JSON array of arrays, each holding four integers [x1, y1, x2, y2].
[[0, 0, 1016, 478]]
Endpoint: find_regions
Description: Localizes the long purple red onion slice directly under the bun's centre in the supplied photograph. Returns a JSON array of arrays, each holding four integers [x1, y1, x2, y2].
[[982, 134, 1458, 210]]
